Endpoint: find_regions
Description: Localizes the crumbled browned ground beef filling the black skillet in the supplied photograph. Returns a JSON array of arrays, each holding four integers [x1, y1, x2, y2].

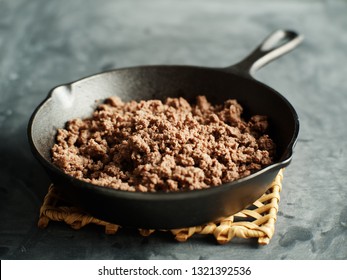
[[52, 96, 275, 192]]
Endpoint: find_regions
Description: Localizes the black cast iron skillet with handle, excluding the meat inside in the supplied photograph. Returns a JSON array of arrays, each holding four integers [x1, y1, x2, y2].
[[28, 30, 302, 229]]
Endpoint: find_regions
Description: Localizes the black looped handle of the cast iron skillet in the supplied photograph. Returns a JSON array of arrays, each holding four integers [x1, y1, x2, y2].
[[230, 30, 304, 75]]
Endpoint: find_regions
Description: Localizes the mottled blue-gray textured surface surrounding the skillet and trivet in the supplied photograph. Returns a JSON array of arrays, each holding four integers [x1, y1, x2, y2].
[[0, 0, 347, 259]]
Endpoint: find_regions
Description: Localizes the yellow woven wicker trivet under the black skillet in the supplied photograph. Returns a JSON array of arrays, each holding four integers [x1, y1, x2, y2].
[[38, 170, 283, 245]]
